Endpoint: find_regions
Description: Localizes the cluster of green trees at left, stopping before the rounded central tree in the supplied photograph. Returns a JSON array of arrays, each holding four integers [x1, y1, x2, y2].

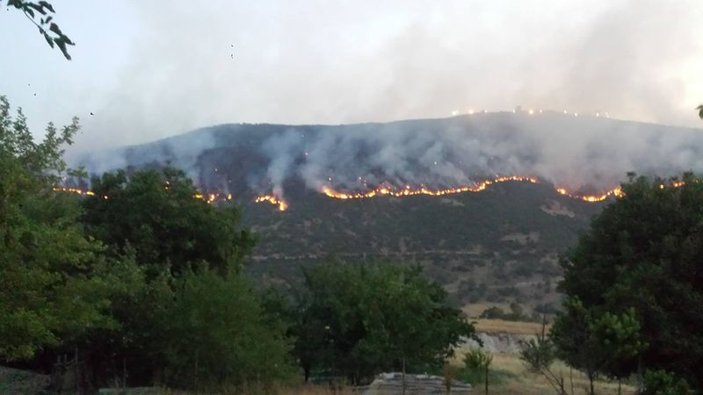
[[0, 97, 291, 391]]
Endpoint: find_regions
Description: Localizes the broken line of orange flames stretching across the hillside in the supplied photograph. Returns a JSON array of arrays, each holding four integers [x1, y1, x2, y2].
[[54, 176, 684, 211]]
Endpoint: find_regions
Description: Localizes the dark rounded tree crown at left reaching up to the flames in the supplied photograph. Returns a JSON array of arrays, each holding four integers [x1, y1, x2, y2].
[[82, 168, 254, 278]]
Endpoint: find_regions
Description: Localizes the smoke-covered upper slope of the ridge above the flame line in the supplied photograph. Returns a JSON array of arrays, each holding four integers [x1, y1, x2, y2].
[[77, 111, 703, 197]]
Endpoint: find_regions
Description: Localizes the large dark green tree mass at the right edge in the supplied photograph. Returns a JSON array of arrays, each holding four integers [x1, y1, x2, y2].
[[522, 174, 703, 395]]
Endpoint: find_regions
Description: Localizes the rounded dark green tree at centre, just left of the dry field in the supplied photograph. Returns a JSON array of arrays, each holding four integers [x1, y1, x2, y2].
[[293, 262, 474, 384]]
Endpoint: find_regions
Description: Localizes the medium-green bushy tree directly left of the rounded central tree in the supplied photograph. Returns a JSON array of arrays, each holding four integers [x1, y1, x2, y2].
[[161, 270, 292, 389]]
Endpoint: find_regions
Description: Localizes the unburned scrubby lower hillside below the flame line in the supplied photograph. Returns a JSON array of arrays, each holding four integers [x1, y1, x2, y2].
[[245, 179, 602, 305]]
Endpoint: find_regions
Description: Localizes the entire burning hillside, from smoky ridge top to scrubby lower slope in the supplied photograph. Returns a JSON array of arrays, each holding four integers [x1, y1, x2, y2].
[[74, 112, 703, 306]]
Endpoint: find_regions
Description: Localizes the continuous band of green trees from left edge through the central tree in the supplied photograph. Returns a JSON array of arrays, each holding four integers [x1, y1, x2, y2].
[[0, 98, 473, 392]]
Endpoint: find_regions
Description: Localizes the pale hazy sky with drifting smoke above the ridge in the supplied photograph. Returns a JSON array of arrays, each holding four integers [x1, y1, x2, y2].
[[0, 0, 703, 152]]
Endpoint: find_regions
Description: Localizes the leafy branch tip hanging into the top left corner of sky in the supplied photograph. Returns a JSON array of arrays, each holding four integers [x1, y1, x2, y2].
[[5, 0, 75, 60]]
